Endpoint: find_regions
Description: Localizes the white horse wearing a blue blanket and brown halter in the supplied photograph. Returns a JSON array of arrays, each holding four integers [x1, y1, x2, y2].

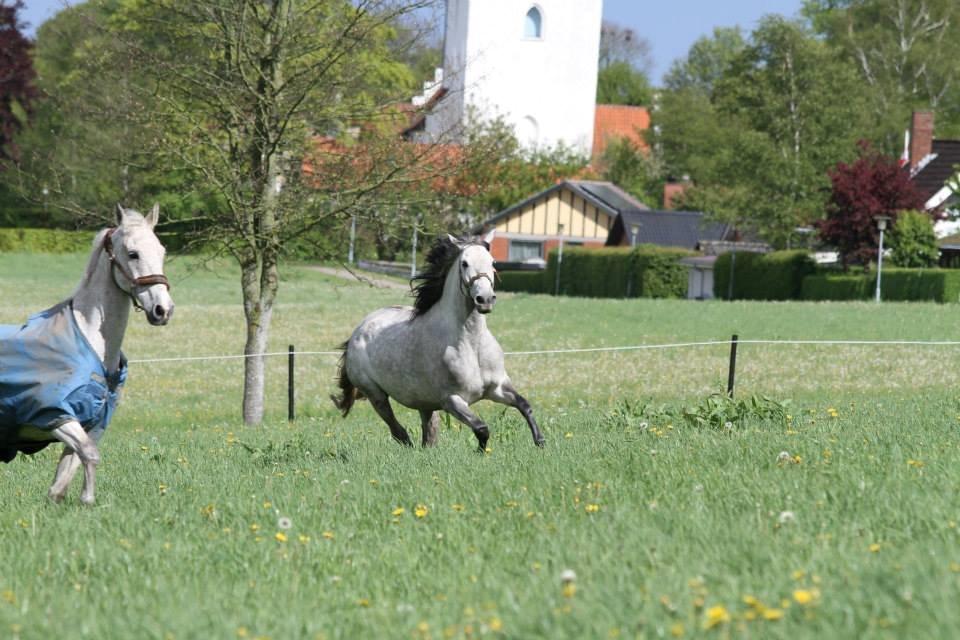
[[0, 205, 174, 504]]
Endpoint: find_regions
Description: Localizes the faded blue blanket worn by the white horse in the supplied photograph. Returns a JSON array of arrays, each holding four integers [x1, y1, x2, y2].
[[0, 300, 127, 462]]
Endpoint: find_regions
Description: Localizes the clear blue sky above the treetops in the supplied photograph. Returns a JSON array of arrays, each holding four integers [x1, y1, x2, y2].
[[22, 0, 803, 83]]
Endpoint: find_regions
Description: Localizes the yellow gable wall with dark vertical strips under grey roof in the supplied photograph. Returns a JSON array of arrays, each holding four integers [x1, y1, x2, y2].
[[496, 189, 613, 240]]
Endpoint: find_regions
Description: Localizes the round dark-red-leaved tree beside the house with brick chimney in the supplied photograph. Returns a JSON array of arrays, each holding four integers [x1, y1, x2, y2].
[[816, 142, 924, 269]]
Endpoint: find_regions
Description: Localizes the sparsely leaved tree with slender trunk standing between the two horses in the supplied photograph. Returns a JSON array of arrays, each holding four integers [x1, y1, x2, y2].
[[106, 0, 442, 423]]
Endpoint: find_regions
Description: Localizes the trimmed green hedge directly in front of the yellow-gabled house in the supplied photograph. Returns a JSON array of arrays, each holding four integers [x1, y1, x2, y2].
[[542, 245, 696, 298]]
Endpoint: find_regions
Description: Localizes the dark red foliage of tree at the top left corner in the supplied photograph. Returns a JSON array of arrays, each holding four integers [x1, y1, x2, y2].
[[0, 0, 38, 168]]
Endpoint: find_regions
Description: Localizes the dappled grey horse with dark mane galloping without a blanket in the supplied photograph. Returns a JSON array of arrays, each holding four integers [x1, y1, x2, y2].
[[333, 232, 544, 451]]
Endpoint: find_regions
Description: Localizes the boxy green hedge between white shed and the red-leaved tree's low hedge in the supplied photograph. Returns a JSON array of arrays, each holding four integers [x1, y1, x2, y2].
[[713, 251, 817, 300]]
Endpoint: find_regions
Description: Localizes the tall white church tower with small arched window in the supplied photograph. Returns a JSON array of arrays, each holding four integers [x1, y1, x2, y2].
[[426, 0, 603, 156]]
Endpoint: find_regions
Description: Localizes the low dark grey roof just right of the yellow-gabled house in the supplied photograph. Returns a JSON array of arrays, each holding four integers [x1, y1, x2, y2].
[[607, 209, 730, 249]]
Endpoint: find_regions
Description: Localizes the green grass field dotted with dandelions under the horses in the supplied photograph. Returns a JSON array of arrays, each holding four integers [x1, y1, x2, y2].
[[0, 255, 960, 640]]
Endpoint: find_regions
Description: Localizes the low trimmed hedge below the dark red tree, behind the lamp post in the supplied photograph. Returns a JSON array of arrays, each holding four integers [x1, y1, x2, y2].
[[802, 268, 960, 302]]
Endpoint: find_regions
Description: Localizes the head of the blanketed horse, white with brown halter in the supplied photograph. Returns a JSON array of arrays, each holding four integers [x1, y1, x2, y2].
[[109, 204, 174, 325]]
